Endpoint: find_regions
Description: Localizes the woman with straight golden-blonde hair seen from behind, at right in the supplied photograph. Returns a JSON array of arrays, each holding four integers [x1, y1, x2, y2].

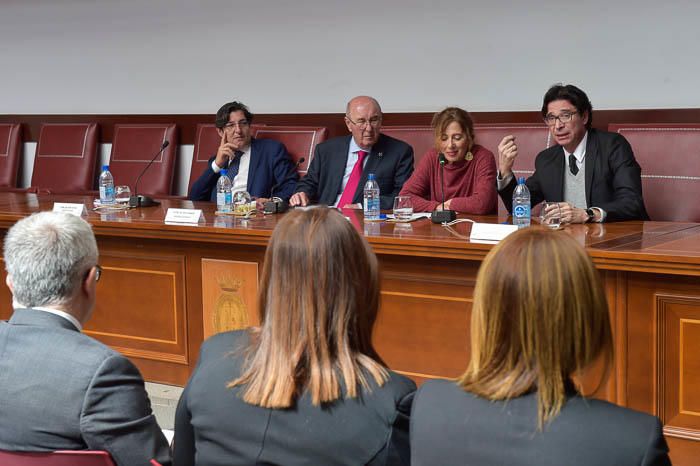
[[411, 228, 670, 466]]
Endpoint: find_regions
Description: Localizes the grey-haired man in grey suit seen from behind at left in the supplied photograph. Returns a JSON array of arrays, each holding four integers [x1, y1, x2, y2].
[[0, 212, 171, 466]]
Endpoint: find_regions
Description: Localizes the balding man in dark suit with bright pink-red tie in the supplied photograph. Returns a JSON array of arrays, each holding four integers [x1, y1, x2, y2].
[[289, 96, 413, 209]]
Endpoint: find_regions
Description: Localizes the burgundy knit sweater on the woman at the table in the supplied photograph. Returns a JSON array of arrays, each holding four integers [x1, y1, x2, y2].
[[401, 144, 498, 215]]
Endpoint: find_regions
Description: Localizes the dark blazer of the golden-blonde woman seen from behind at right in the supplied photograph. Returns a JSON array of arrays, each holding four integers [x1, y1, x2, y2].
[[411, 380, 671, 466]]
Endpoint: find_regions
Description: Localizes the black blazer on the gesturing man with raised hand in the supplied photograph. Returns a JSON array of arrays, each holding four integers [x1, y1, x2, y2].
[[499, 129, 649, 221]]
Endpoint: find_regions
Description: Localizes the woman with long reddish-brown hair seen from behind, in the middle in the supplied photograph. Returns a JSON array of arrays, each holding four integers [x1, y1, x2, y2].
[[173, 209, 415, 466]]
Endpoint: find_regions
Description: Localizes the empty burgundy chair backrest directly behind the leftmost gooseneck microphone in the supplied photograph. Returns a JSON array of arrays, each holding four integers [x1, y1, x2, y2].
[[109, 124, 178, 196]]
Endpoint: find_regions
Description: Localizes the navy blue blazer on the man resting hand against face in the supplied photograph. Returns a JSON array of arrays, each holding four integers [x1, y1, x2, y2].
[[190, 139, 299, 202]]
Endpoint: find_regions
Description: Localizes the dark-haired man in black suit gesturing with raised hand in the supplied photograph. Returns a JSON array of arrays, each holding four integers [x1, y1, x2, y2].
[[496, 84, 649, 223]]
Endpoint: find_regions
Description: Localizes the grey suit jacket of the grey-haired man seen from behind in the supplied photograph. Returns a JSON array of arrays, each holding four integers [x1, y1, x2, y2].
[[0, 309, 171, 466]]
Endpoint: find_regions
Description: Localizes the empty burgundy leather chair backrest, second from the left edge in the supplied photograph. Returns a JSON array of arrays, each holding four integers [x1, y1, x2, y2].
[[31, 123, 97, 194]]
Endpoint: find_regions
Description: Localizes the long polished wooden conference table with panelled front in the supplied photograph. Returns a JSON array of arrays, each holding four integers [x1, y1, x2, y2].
[[0, 193, 700, 464]]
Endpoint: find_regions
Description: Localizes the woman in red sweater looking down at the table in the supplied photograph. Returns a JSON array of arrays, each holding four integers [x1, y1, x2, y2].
[[401, 107, 498, 215]]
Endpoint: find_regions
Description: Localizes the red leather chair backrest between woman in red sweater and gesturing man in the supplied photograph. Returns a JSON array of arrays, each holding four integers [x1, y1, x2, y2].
[[474, 124, 551, 215]]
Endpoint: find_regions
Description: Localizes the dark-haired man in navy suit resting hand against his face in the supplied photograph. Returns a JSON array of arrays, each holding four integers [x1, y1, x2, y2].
[[190, 102, 298, 208]]
